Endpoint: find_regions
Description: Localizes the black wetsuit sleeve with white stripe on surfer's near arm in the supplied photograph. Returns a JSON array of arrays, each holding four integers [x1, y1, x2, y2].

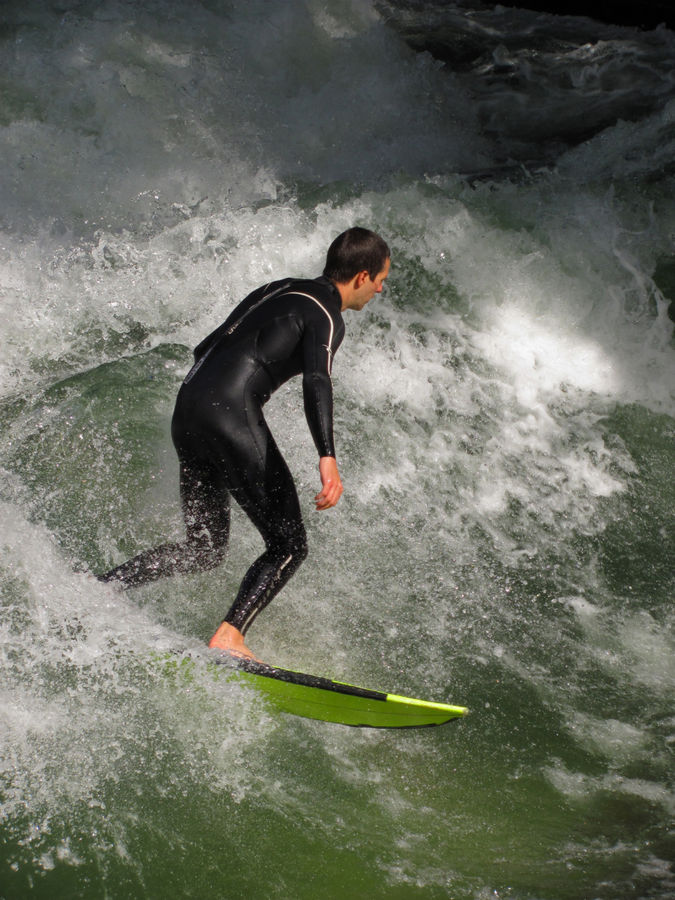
[[302, 313, 343, 456]]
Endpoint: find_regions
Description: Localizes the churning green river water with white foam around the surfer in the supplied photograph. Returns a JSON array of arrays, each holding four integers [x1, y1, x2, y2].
[[0, 0, 675, 900]]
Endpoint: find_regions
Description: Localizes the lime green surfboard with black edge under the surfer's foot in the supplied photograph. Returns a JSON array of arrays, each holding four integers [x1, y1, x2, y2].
[[215, 657, 468, 728]]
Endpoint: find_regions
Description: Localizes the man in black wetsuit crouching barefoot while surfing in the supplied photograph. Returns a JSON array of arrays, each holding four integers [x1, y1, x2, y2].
[[99, 227, 390, 657]]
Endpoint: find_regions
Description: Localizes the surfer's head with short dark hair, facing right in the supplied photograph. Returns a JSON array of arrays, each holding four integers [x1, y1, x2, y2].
[[323, 226, 391, 310]]
